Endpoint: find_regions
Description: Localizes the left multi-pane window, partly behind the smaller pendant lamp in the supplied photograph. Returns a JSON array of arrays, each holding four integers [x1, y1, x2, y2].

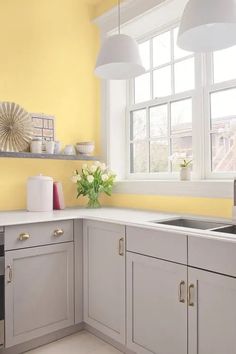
[[129, 28, 195, 175]]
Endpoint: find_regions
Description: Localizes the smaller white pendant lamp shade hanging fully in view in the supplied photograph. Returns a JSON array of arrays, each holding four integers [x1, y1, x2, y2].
[[95, 34, 145, 80]]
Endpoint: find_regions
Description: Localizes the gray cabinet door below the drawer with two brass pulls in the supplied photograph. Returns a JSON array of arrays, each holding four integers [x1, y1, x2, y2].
[[5, 242, 74, 347]]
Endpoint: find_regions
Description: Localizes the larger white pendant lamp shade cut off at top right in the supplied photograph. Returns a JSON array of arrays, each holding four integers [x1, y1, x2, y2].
[[178, 0, 236, 52]]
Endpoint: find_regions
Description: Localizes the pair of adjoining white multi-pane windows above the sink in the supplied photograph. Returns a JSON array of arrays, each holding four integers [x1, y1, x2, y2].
[[127, 26, 236, 178]]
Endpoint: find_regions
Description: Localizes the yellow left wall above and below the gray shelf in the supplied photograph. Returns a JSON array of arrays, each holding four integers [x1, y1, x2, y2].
[[0, 0, 100, 210]]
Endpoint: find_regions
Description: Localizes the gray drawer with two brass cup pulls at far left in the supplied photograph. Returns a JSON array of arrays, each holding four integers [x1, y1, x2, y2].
[[5, 220, 73, 250]]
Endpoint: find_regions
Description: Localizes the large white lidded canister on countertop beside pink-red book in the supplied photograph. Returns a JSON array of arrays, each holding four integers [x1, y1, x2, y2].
[[27, 175, 53, 211]]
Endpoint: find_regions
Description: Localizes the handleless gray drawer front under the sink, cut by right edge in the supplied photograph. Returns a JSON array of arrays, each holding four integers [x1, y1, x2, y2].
[[188, 237, 236, 277]]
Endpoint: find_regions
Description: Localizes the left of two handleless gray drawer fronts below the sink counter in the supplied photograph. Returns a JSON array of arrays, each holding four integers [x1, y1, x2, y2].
[[127, 227, 187, 264]]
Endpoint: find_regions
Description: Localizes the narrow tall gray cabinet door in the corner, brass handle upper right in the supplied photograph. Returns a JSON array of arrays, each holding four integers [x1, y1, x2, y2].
[[83, 221, 125, 344]]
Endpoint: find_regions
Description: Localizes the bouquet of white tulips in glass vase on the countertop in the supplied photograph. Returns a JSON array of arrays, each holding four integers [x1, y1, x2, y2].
[[71, 161, 116, 208]]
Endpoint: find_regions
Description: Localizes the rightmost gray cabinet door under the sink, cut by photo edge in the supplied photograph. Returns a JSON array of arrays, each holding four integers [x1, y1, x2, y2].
[[188, 267, 236, 354]]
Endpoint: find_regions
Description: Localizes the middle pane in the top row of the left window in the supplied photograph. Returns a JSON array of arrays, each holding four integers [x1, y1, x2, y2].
[[153, 32, 171, 67]]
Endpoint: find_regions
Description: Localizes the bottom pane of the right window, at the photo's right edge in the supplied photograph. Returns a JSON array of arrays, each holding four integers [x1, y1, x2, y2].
[[211, 131, 236, 172]]
